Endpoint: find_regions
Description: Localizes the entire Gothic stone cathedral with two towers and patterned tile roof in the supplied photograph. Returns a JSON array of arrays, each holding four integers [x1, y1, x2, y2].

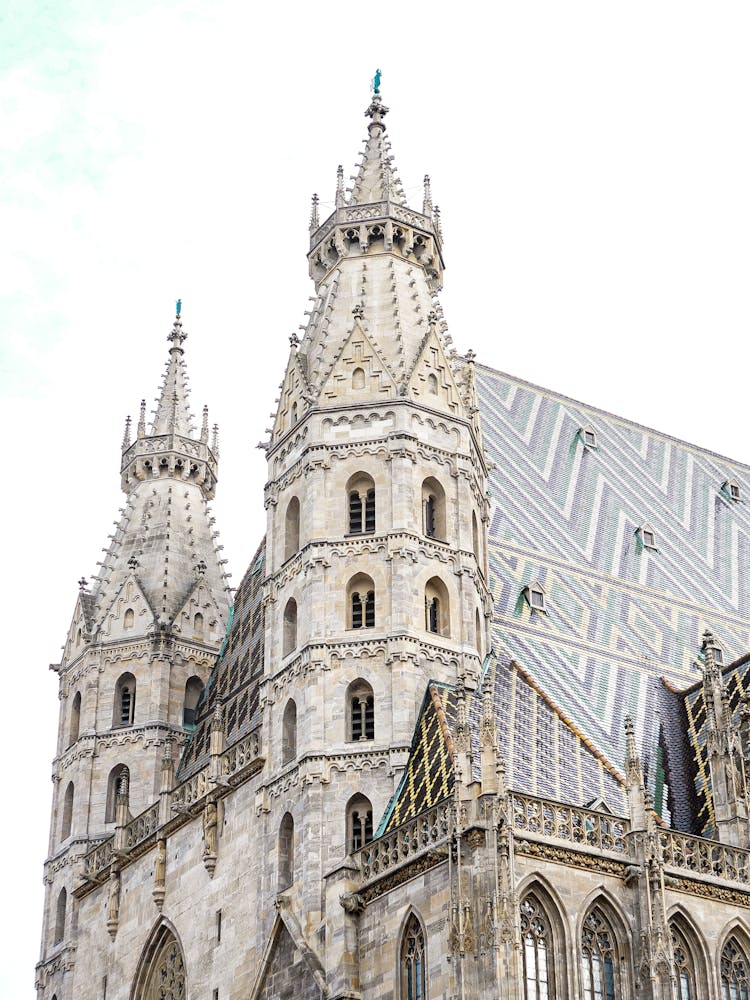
[[36, 87, 750, 1000]]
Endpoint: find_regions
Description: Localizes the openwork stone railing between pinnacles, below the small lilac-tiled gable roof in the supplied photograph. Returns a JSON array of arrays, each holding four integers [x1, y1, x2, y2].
[[511, 792, 630, 855]]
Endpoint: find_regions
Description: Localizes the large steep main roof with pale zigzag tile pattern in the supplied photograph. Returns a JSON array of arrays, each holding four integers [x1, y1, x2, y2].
[[475, 364, 750, 812]]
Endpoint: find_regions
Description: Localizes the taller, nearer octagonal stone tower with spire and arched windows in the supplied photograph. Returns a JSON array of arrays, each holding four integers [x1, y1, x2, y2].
[[261, 94, 491, 995]]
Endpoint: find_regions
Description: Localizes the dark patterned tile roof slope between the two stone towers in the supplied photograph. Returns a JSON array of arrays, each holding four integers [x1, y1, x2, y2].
[[177, 539, 265, 780]]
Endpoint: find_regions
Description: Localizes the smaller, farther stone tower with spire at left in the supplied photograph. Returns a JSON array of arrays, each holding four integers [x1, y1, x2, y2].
[[41, 303, 228, 967]]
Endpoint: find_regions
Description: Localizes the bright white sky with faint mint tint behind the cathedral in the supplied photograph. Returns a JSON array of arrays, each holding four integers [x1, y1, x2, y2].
[[0, 0, 750, 998]]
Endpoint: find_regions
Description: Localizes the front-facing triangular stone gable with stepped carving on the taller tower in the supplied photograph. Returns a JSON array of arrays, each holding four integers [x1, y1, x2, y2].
[[320, 318, 396, 404]]
